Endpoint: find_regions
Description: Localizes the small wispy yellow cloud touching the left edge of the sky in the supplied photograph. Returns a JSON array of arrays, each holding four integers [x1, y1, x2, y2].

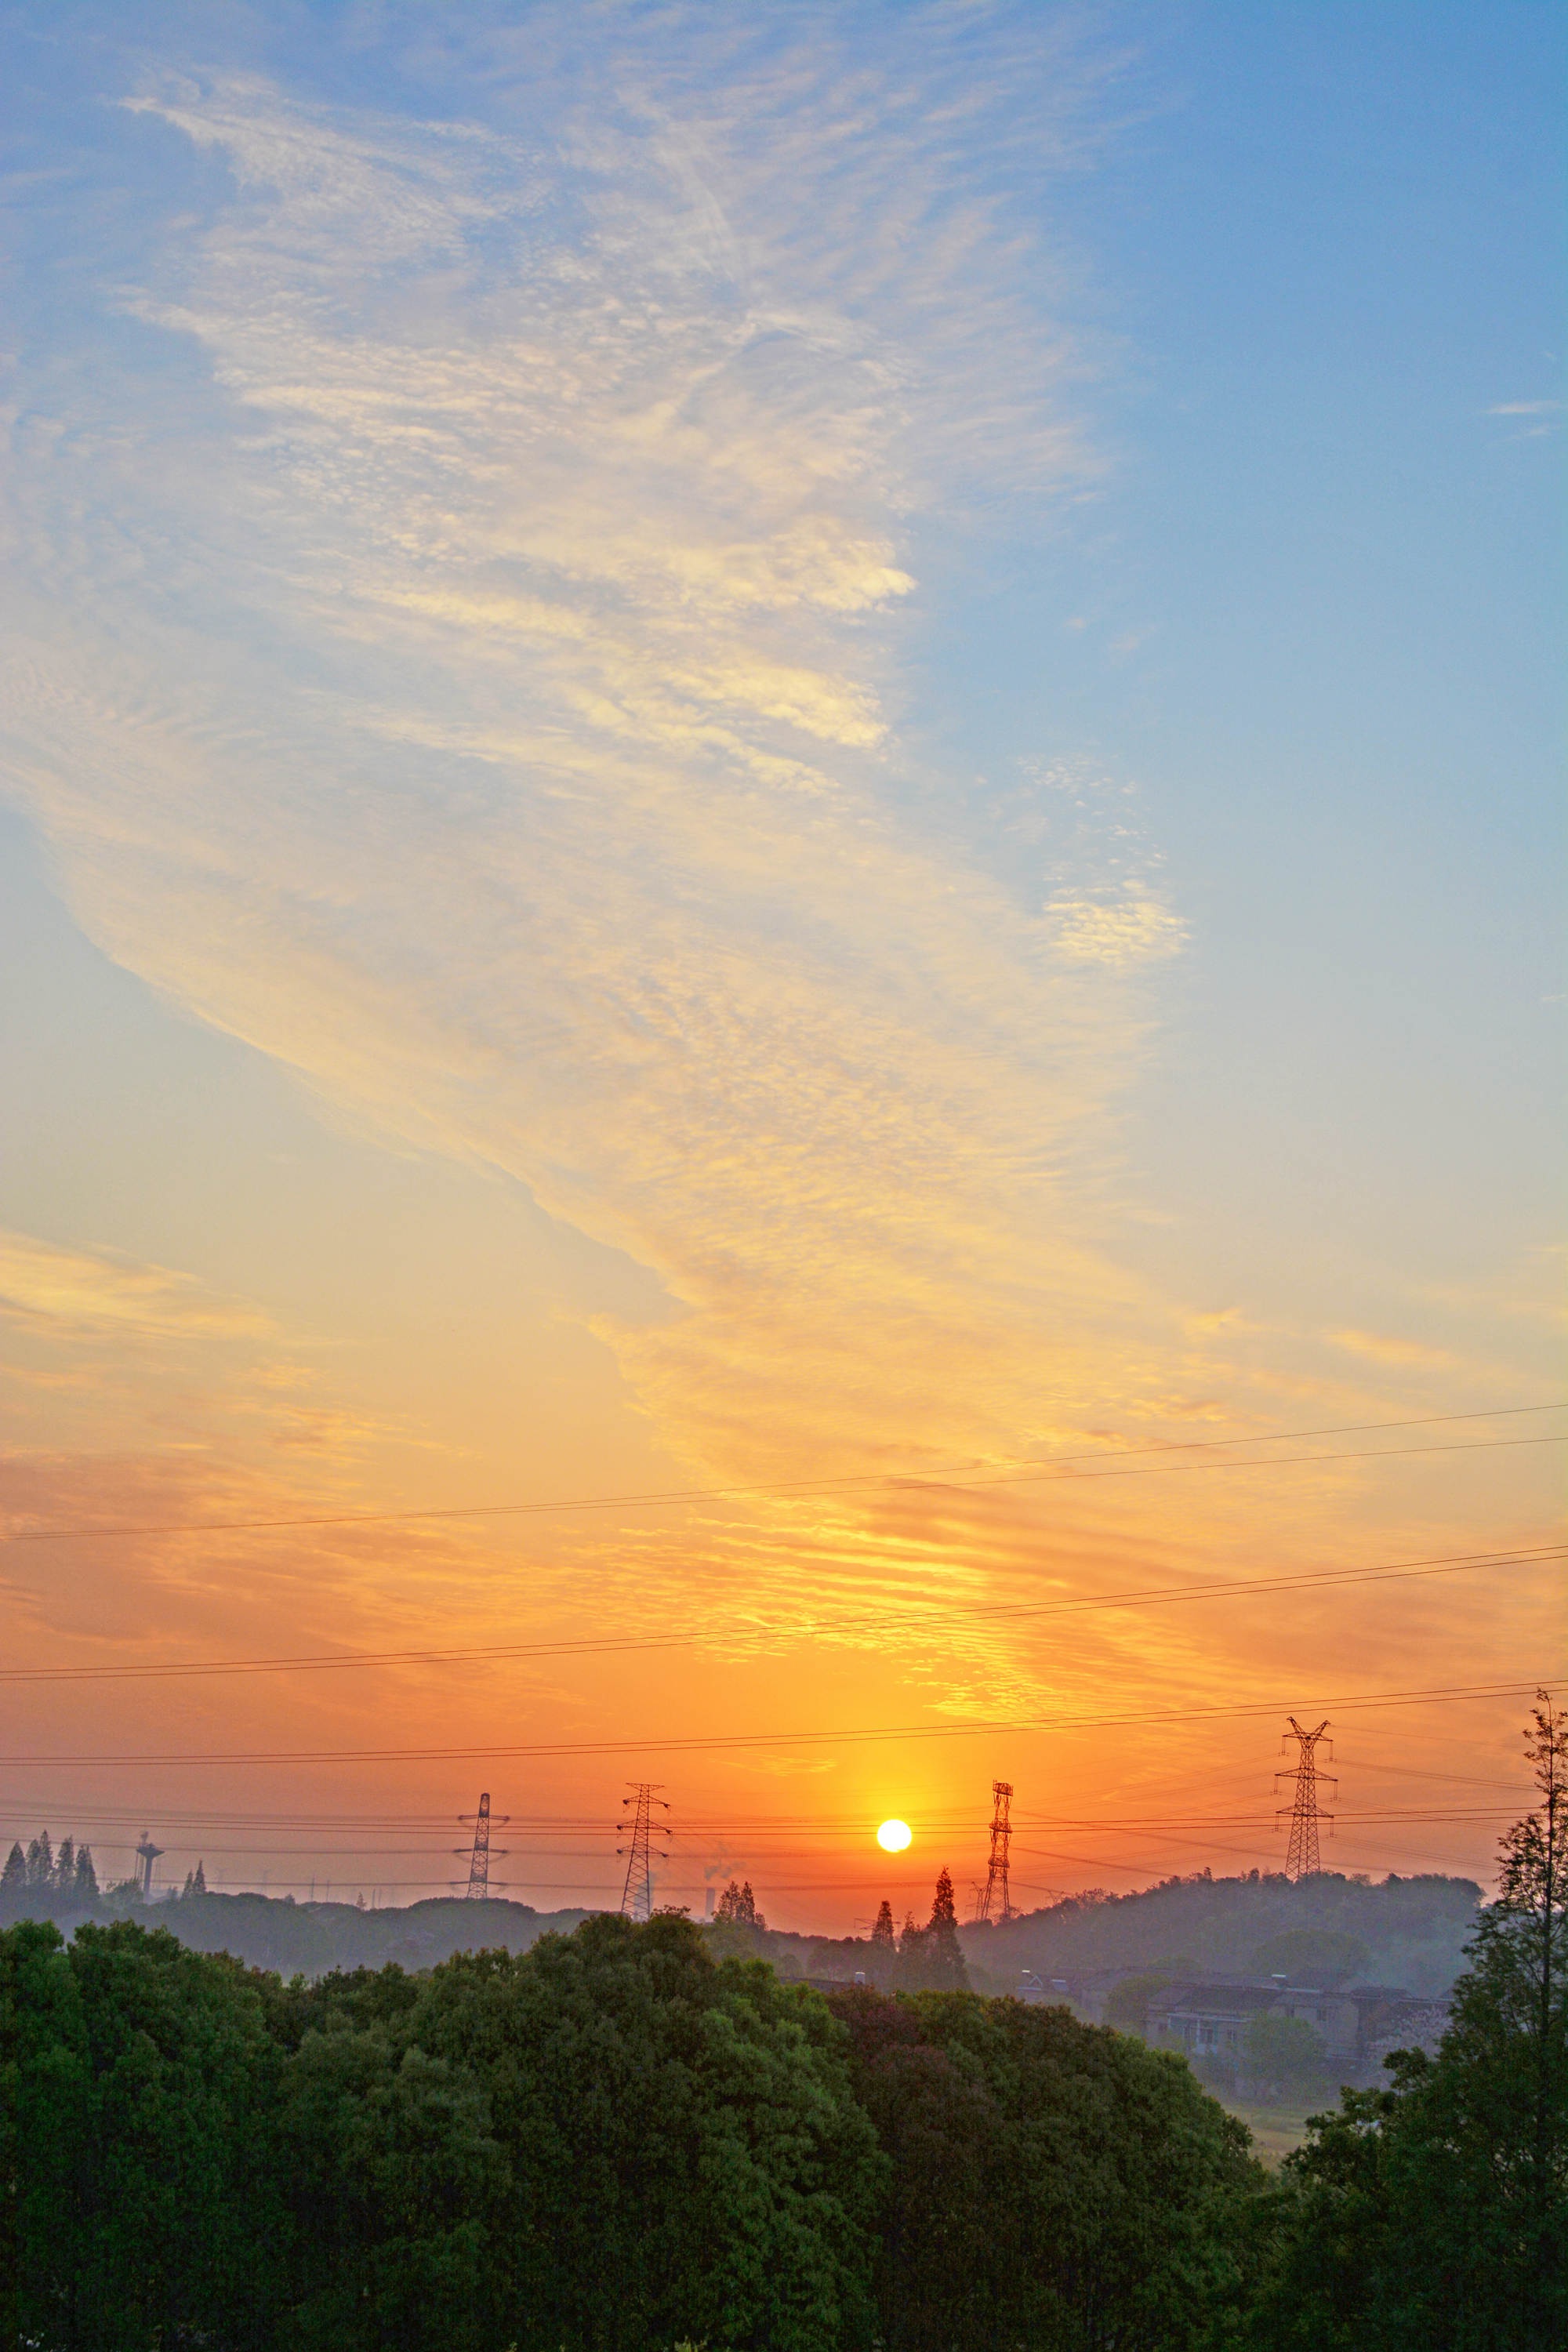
[[0, 1232, 270, 1338]]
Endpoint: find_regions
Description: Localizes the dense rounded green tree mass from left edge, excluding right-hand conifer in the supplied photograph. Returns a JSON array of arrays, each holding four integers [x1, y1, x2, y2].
[[0, 1917, 1258, 2352]]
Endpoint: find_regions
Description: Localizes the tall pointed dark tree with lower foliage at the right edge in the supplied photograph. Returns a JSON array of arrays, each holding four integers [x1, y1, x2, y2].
[[1260, 1693, 1568, 2352]]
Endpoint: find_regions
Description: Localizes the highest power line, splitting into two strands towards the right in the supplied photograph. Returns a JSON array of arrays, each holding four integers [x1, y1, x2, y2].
[[5, 1399, 1568, 1543]]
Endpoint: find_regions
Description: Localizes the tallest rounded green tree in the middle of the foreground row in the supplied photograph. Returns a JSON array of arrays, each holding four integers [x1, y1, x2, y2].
[[408, 1915, 884, 2352]]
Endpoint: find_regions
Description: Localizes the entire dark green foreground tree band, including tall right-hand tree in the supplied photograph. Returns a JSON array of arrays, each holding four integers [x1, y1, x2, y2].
[[0, 1712, 1568, 2352]]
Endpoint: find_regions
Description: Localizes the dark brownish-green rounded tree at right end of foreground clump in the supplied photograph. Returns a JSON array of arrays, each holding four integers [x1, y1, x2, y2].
[[827, 1985, 1262, 2352]]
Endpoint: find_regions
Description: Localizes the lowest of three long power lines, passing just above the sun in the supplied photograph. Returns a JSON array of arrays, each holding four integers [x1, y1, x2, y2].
[[0, 1675, 1542, 1771]]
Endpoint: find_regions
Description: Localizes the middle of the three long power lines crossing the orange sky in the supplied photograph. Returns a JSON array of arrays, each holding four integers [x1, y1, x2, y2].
[[0, 1543, 1568, 1684]]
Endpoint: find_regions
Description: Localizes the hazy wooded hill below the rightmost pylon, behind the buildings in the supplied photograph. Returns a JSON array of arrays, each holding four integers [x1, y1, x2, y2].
[[961, 1870, 1481, 1997]]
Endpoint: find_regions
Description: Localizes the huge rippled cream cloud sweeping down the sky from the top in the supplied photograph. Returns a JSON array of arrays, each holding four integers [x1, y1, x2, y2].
[[5, 12, 1182, 1468]]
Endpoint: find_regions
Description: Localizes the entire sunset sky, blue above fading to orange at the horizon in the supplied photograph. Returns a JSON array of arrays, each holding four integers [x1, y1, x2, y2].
[[0, 0, 1568, 1933]]
